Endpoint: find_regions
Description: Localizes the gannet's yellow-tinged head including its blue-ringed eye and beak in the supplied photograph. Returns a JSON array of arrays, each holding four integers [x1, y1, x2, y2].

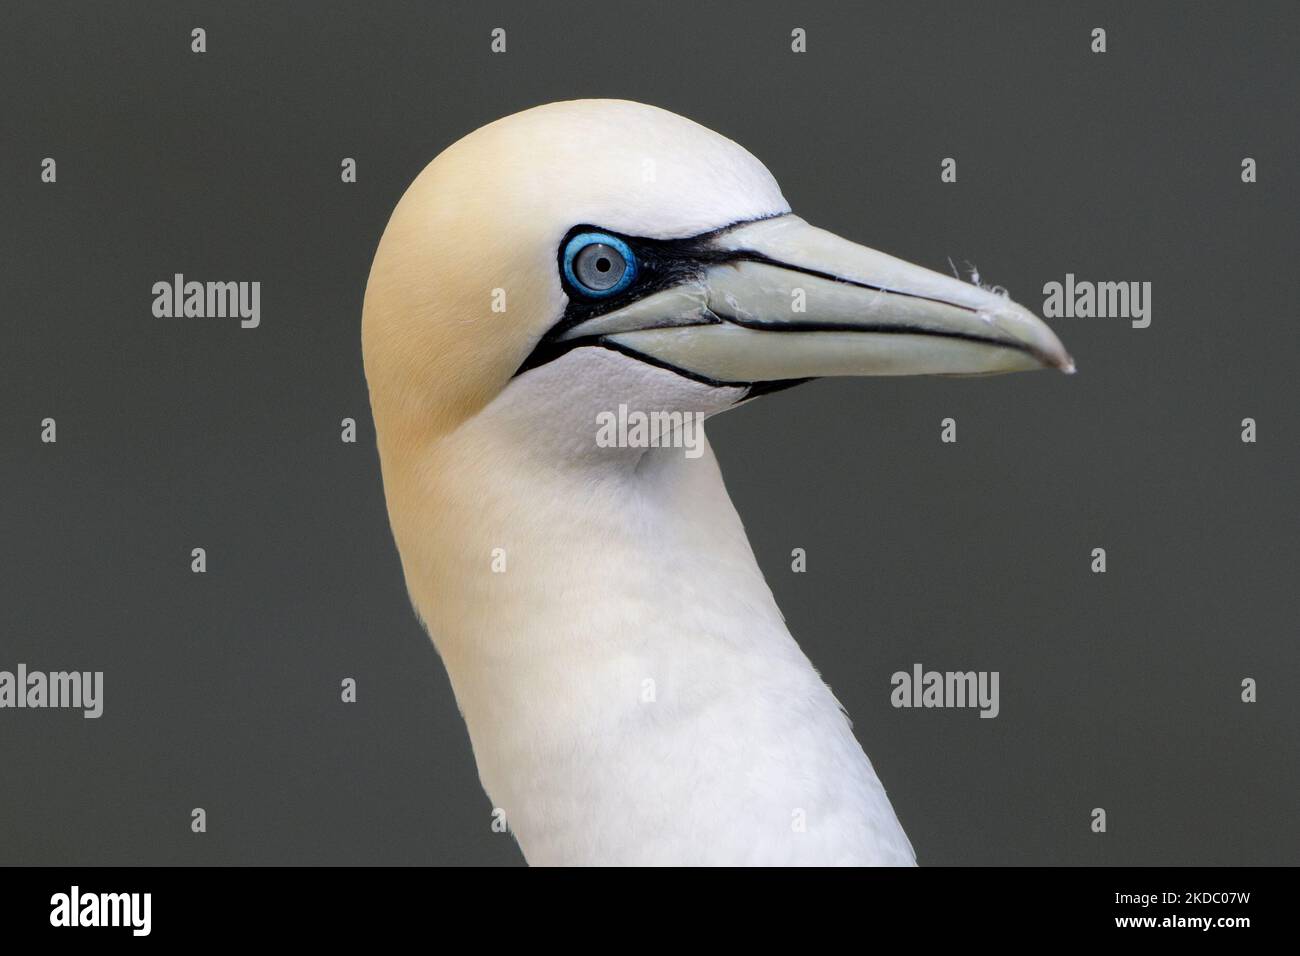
[[363, 100, 1073, 449]]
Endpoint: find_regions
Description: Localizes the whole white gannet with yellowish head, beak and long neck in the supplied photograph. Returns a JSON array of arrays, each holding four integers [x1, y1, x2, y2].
[[363, 100, 1073, 865]]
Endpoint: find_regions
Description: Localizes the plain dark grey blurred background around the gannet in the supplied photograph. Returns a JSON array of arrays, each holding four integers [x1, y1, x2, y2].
[[0, 0, 1300, 864]]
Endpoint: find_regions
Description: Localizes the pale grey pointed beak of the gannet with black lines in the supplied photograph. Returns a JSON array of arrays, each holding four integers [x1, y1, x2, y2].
[[563, 216, 1074, 384]]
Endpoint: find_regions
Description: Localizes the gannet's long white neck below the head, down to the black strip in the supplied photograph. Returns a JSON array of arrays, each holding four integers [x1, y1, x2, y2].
[[380, 361, 910, 864]]
